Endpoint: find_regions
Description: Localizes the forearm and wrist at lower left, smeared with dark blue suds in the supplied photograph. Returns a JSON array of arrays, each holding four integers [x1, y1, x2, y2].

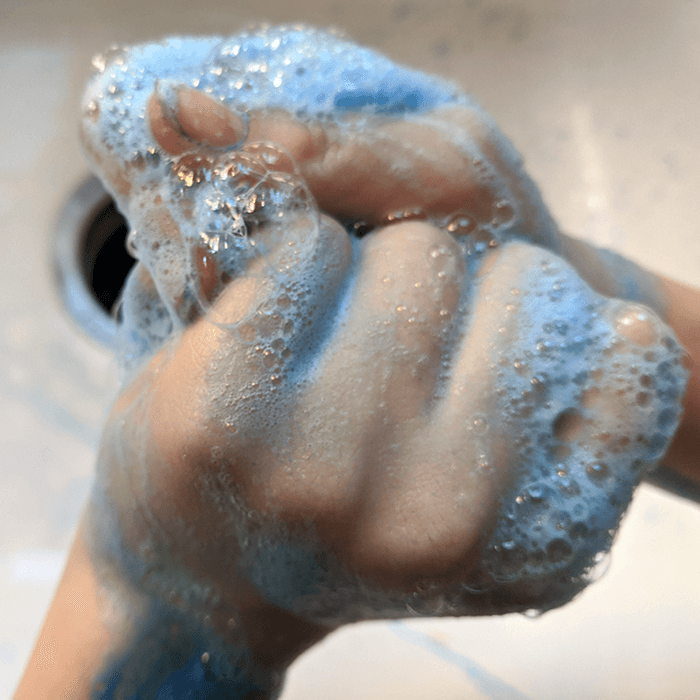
[[14, 508, 328, 700]]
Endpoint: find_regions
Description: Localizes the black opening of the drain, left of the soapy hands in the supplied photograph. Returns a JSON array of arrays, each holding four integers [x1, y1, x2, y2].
[[82, 198, 136, 312]]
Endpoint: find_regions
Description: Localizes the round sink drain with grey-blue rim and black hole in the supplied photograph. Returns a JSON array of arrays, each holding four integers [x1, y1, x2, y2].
[[54, 177, 135, 345]]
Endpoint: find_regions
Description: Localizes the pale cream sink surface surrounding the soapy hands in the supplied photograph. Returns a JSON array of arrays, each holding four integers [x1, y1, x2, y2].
[[0, 0, 700, 700]]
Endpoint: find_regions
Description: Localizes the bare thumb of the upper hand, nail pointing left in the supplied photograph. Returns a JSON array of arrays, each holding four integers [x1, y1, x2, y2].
[[149, 95, 528, 235]]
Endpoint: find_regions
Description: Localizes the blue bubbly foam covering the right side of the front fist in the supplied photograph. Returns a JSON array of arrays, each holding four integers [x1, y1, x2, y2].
[[484, 257, 687, 582]]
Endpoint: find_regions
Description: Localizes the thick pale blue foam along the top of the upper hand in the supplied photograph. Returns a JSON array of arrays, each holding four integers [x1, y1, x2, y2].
[[84, 25, 473, 161]]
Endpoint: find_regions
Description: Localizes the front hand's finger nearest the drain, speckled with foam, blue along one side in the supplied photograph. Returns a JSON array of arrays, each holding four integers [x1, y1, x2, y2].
[[155, 213, 351, 424]]
